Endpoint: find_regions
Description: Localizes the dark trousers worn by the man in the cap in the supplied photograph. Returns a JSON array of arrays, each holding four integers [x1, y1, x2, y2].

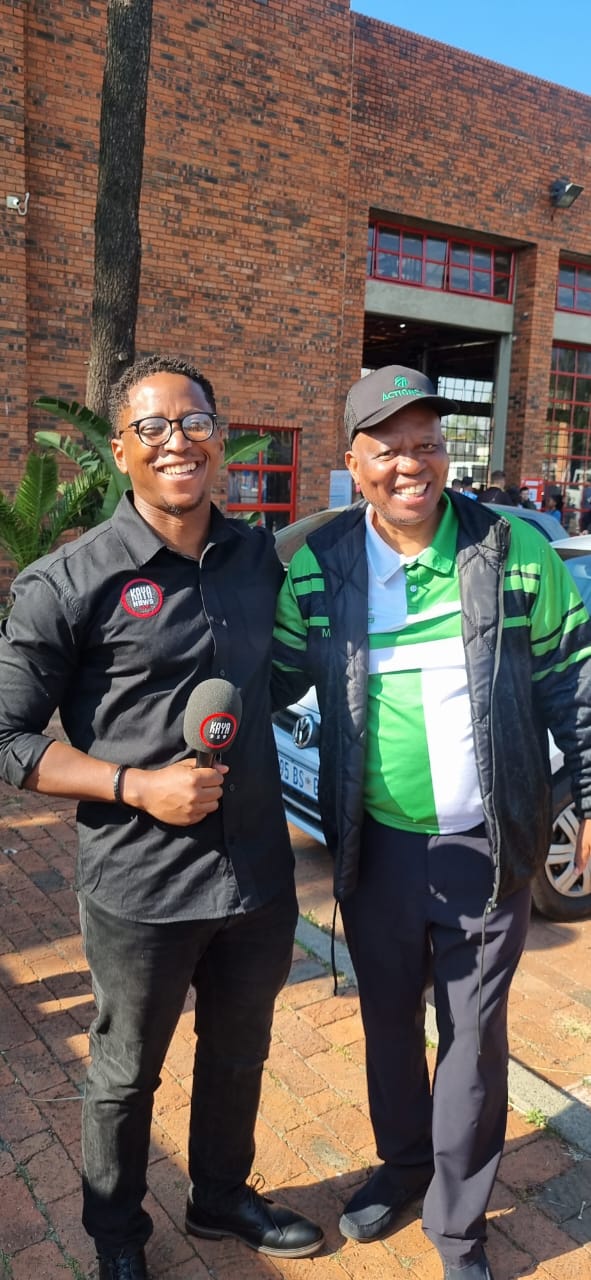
[[342, 818, 531, 1265]]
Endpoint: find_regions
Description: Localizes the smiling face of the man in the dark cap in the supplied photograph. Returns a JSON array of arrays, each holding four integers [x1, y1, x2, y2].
[[345, 403, 449, 554]]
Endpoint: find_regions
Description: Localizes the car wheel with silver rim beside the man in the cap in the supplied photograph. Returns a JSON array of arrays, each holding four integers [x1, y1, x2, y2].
[[532, 771, 591, 920]]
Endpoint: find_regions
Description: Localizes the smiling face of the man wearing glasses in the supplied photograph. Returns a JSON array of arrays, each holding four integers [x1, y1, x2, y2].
[[111, 372, 224, 541]]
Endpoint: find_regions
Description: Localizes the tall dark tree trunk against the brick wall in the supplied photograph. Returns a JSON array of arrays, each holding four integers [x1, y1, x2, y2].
[[86, 0, 152, 417]]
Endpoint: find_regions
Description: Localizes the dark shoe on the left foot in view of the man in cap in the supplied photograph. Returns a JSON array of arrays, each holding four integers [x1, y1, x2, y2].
[[339, 1165, 432, 1239]]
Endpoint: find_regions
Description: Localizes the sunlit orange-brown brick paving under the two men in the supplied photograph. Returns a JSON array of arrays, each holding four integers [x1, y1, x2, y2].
[[0, 786, 591, 1280]]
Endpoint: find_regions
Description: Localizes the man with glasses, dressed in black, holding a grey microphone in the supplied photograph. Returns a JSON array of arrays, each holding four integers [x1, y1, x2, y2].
[[0, 356, 322, 1280]]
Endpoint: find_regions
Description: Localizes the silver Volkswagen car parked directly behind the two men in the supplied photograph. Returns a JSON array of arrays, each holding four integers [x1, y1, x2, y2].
[[274, 506, 591, 920]]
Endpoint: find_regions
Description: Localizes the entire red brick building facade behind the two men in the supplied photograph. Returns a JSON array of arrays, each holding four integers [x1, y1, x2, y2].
[[0, 0, 591, 589]]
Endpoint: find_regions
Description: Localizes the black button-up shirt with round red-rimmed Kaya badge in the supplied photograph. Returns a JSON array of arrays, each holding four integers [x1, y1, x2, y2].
[[0, 494, 293, 922]]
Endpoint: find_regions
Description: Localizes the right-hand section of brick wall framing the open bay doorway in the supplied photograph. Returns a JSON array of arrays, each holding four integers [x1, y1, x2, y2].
[[347, 14, 591, 481]]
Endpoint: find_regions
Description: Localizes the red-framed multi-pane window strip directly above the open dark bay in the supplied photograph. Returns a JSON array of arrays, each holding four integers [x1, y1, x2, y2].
[[367, 221, 516, 303]]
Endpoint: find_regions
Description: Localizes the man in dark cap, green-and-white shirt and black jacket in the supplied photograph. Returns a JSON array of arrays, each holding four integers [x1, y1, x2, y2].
[[274, 366, 591, 1280]]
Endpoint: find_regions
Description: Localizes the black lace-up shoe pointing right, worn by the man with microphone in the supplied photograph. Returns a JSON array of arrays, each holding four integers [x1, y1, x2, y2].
[[185, 1185, 324, 1258]]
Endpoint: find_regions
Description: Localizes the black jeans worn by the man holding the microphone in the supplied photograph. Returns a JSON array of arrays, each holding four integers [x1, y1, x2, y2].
[[81, 893, 297, 1257]]
